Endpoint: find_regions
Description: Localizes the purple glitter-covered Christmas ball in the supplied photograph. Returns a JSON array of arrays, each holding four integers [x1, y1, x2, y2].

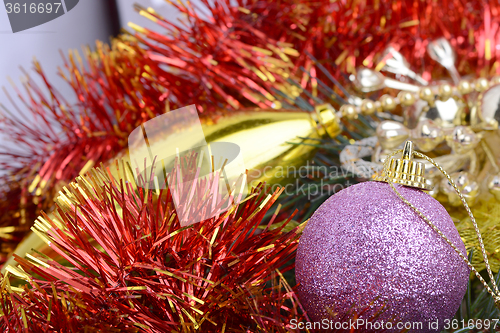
[[295, 181, 469, 332]]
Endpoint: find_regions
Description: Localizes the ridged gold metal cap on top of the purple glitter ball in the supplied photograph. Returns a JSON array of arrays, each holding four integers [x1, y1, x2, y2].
[[377, 140, 432, 191]]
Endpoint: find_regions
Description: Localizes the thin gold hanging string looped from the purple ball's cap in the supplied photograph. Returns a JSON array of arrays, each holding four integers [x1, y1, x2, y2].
[[383, 149, 500, 306]]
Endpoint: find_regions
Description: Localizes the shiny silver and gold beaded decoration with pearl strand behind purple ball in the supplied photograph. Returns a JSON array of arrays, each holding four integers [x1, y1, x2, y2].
[[336, 38, 499, 213]]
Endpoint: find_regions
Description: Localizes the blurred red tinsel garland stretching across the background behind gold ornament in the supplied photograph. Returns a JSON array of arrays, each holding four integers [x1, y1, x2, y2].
[[0, 0, 500, 260]]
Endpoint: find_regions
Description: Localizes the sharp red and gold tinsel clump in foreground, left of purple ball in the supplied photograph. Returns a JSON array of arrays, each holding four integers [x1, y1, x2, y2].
[[0, 161, 305, 333]]
